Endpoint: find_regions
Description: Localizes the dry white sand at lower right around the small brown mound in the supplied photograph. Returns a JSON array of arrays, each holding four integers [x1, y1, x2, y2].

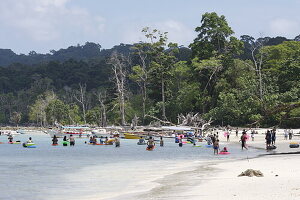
[[189, 130, 300, 200]]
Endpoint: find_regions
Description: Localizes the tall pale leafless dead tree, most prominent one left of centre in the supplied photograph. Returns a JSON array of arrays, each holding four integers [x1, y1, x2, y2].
[[108, 52, 129, 126]]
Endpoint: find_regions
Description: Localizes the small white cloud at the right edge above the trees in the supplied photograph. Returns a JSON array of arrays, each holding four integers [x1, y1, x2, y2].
[[269, 19, 300, 37]]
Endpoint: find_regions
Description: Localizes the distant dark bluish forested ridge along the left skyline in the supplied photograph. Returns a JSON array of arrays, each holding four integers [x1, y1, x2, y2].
[[0, 42, 132, 67]]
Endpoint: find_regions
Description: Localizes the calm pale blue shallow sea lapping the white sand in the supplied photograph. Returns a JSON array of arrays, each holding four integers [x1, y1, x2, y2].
[[0, 135, 261, 200]]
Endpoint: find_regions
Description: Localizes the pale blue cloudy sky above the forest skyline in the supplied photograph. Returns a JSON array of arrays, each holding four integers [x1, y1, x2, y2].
[[0, 0, 300, 54]]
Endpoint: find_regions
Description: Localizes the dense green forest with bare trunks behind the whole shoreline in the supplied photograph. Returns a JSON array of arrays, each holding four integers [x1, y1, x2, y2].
[[0, 13, 300, 127]]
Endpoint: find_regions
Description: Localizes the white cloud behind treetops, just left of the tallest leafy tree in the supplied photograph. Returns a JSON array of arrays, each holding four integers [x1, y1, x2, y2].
[[122, 20, 196, 46]]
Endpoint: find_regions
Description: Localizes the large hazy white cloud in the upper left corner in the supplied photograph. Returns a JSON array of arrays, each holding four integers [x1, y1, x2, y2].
[[0, 0, 105, 41]]
